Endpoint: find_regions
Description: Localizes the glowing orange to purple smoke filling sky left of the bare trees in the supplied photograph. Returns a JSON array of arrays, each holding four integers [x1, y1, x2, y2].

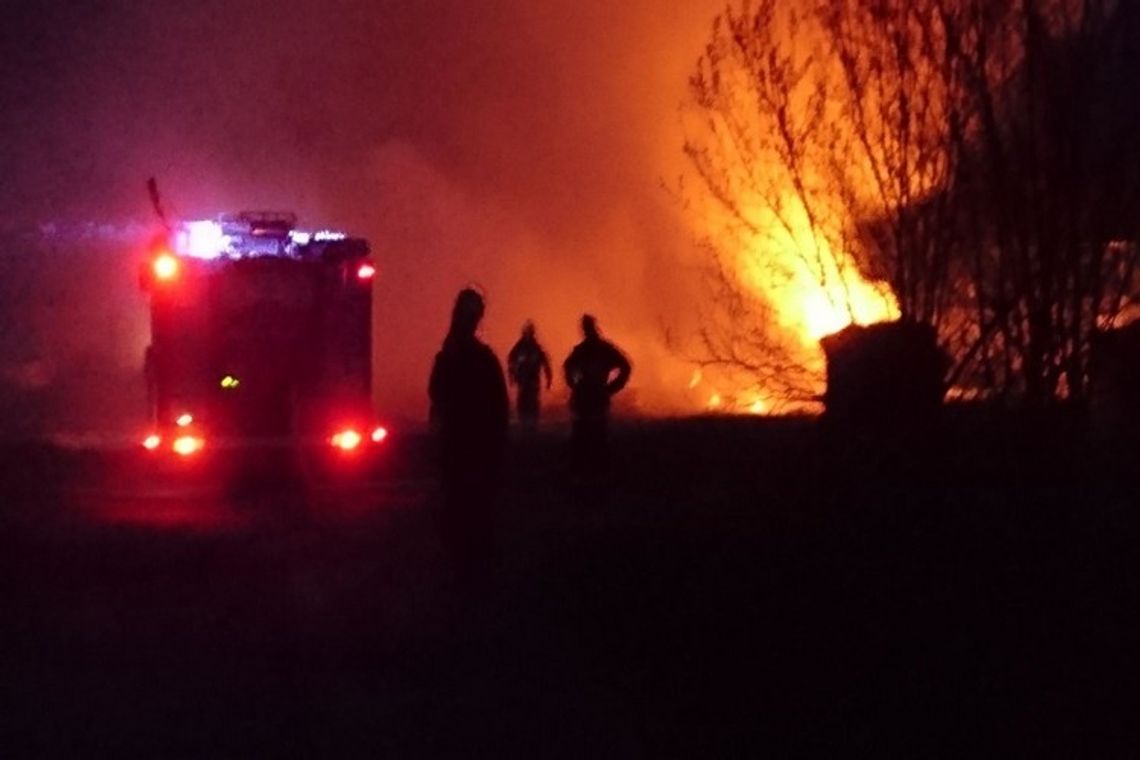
[[0, 0, 720, 432]]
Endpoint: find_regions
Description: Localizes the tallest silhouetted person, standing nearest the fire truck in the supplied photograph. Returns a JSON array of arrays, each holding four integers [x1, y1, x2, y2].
[[428, 288, 510, 585]]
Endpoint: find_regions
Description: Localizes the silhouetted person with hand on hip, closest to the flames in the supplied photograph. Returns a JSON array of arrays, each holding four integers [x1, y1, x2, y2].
[[562, 314, 630, 472]]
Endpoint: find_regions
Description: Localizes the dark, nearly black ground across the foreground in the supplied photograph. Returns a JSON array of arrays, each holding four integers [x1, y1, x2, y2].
[[0, 419, 1140, 758]]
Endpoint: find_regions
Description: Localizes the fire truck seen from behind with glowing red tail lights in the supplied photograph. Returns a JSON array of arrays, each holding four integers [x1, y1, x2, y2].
[[140, 212, 388, 459]]
